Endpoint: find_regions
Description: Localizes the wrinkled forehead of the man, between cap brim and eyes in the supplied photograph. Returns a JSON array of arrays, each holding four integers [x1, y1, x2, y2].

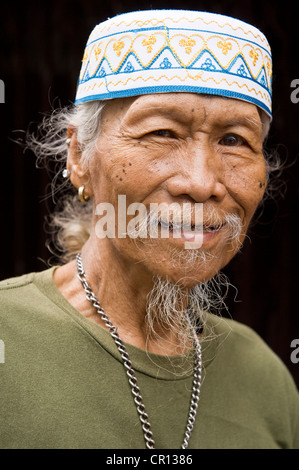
[[102, 92, 269, 139]]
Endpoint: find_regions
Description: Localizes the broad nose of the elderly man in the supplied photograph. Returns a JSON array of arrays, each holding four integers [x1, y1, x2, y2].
[[167, 145, 227, 203]]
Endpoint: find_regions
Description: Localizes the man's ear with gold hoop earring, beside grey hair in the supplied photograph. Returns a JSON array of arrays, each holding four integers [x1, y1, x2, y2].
[[67, 127, 92, 197]]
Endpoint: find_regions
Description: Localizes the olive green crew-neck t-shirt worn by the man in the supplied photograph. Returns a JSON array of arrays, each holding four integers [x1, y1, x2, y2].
[[0, 269, 299, 449]]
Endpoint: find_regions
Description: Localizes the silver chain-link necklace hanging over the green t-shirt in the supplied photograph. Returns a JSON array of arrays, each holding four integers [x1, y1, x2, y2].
[[76, 253, 202, 449]]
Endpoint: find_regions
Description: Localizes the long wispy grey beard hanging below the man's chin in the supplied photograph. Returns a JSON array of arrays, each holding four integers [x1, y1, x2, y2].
[[146, 273, 230, 354]]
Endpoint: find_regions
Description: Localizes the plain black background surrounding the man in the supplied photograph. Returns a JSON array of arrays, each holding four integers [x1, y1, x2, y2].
[[0, 0, 299, 385]]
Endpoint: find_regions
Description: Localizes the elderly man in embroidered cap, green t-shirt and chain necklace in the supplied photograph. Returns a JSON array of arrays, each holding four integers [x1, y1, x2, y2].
[[0, 10, 299, 449]]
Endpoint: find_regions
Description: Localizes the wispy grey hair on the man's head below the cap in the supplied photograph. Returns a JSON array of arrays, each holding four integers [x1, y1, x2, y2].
[[27, 101, 281, 262]]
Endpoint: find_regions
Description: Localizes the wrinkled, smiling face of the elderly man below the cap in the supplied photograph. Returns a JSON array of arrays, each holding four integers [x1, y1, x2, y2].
[[89, 93, 266, 286]]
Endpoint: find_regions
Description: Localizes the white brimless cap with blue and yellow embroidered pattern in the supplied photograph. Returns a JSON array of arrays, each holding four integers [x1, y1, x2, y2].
[[76, 10, 272, 118]]
